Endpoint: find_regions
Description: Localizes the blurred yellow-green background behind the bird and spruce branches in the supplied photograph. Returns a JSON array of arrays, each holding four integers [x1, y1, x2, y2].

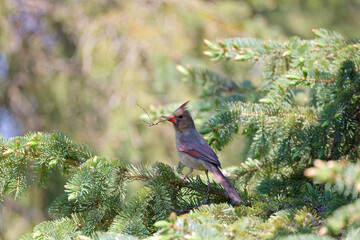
[[0, 0, 360, 239]]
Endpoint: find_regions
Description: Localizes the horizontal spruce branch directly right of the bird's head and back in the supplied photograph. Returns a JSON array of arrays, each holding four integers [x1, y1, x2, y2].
[[202, 99, 318, 150]]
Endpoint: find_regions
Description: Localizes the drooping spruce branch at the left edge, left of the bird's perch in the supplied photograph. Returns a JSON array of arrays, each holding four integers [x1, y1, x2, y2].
[[0, 132, 97, 197]]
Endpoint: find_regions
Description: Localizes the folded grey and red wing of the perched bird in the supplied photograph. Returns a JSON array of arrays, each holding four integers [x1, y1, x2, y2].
[[178, 137, 220, 167]]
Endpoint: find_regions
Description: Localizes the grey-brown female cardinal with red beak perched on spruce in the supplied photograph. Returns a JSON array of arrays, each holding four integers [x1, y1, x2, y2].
[[166, 101, 242, 203]]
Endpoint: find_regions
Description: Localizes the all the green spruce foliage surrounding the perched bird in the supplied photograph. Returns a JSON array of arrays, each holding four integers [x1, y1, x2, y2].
[[0, 29, 360, 239]]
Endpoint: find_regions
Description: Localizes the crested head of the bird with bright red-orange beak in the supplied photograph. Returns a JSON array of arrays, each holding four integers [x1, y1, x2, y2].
[[166, 101, 195, 131]]
